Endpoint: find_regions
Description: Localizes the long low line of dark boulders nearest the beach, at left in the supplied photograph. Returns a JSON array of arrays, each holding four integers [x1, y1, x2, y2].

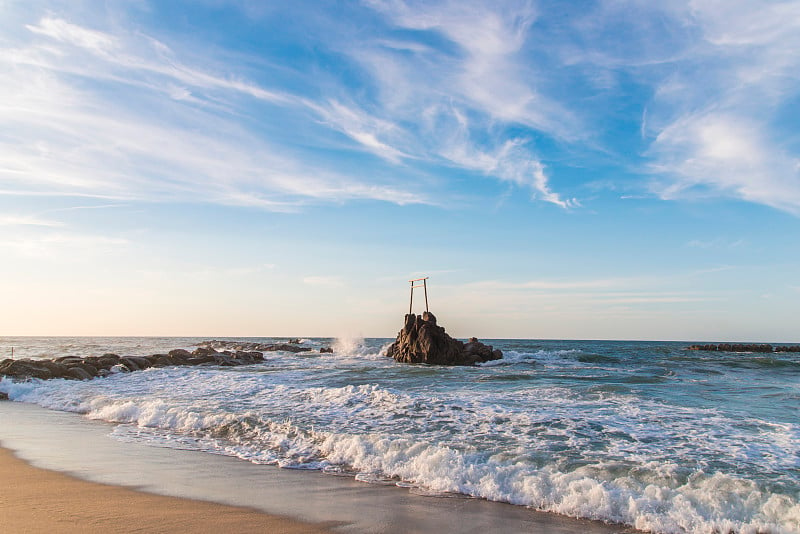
[[0, 347, 264, 390]]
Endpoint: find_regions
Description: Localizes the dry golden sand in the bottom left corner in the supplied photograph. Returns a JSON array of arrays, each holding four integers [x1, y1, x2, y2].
[[0, 448, 328, 534]]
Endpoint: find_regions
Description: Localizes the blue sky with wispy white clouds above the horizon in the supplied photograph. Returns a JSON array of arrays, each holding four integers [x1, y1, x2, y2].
[[0, 0, 800, 342]]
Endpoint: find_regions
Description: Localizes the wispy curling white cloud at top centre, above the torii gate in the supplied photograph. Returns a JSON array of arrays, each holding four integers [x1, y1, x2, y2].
[[343, 0, 579, 208]]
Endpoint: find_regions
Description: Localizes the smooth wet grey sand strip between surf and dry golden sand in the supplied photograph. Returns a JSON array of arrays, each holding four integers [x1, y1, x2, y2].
[[0, 401, 639, 534]]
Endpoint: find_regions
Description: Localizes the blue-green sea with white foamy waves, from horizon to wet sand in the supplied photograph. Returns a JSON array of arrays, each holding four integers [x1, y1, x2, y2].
[[0, 337, 800, 534]]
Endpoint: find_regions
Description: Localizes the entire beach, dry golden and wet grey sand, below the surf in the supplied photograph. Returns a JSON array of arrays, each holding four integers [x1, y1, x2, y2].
[[0, 401, 636, 534]]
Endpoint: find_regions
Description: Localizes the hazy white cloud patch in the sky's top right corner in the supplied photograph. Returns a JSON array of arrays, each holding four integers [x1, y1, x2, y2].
[[636, 0, 800, 215]]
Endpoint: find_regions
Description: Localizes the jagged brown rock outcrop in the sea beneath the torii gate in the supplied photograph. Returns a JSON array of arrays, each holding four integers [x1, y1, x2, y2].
[[386, 312, 503, 365]]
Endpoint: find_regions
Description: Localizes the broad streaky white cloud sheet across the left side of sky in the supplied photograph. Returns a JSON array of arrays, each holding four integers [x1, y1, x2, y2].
[[0, 12, 427, 211]]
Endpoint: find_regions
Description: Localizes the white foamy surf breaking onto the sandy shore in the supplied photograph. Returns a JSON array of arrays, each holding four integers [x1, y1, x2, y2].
[[0, 376, 800, 533]]
